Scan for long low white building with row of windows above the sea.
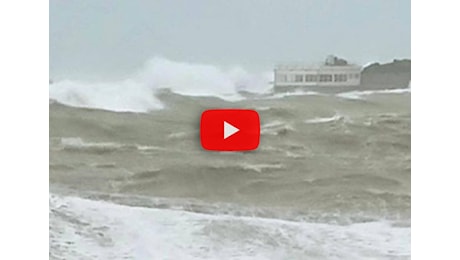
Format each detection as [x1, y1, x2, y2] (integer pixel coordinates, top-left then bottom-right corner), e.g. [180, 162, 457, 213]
[274, 56, 361, 90]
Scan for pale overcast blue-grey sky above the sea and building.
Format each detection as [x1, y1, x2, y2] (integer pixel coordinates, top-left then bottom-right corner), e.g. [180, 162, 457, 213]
[50, 0, 411, 78]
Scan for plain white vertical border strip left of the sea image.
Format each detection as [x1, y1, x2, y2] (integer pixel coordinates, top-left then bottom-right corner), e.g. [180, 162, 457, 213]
[0, 1, 49, 259]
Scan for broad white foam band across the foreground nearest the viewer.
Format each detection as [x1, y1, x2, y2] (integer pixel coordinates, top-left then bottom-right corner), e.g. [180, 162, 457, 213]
[50, 195, 410, 259]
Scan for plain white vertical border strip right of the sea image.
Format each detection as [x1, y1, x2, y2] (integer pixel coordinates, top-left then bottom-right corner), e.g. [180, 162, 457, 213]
[411, 1, 460, 259]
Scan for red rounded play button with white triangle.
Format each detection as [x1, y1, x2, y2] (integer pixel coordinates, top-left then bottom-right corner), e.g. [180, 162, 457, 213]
[200, 109, 260, 151]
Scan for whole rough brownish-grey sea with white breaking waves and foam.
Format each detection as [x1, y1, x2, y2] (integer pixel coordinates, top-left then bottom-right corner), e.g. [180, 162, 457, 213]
[49, 59, 411, 259]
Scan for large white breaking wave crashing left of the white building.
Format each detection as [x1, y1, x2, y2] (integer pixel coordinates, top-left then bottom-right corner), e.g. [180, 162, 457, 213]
[49, 57, 272, 112]
